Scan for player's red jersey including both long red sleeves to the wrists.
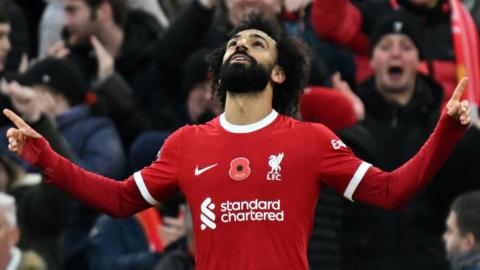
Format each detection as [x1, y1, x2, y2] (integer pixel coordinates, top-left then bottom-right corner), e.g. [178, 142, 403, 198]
[29, 108, 466, 270]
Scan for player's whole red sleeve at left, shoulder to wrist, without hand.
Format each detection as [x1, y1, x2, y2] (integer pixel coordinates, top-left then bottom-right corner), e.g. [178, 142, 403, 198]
[22, 127, 186, 217]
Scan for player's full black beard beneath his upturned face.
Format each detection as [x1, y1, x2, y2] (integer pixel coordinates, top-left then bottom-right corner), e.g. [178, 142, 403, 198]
[218, 52, 273, 94]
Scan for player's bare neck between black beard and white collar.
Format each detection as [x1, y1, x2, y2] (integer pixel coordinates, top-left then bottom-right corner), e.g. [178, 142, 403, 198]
[225, 84, 273, 125]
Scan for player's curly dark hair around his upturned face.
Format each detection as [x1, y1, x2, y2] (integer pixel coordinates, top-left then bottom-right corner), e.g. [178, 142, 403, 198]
[209, 13, 310, 115]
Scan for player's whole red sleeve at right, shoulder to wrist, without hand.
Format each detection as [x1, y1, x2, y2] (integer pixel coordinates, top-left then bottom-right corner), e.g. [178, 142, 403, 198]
[319, 113, 466, 209]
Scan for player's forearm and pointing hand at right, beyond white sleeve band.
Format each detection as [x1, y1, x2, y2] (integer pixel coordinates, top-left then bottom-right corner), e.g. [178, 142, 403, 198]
[354, 78, 470, 209]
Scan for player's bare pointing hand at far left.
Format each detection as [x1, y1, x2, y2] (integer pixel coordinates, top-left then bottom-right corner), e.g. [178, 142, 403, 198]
[3, 109, 42, 155]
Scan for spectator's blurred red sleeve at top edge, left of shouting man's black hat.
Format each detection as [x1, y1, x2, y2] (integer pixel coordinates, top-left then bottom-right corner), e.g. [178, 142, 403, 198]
[311, 0, 368, 54]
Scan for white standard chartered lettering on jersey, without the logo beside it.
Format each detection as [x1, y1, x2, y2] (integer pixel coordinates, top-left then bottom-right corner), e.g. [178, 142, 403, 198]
[220, 199, 285, 223]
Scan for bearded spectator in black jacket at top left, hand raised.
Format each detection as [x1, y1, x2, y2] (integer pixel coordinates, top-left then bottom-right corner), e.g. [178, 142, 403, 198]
[60, 0, 185, 134]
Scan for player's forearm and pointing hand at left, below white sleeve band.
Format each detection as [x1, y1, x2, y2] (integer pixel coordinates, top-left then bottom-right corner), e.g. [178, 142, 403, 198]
[3, 109, 150, 217]
